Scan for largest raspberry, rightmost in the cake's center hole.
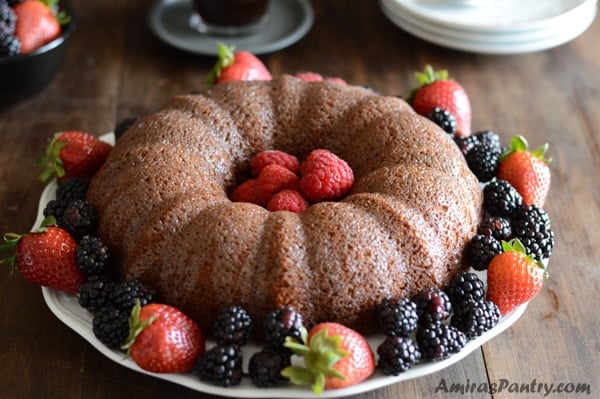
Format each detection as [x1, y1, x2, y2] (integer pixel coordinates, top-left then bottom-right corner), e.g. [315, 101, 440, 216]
[300, 149, 354, 202]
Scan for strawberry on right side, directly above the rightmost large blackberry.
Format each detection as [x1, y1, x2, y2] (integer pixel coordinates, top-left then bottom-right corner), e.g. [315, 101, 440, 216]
[497, 136, 550, 208]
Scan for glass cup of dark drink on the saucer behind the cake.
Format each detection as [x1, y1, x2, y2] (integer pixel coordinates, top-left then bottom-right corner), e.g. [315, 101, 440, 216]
[190, 0, 270, 36]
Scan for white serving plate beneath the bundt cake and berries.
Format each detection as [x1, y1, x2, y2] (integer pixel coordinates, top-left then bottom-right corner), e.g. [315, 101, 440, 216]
[34, 133, 527, 399]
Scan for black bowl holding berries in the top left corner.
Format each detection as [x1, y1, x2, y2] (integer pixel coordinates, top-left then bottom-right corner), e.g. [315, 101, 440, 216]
[0, 1, 77, 109]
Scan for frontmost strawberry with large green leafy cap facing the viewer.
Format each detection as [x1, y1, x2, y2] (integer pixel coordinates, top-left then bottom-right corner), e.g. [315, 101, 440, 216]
[281, 323, 375, 394]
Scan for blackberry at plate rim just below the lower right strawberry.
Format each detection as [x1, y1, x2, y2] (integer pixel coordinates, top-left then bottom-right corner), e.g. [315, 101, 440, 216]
[450, 300, 500, 338]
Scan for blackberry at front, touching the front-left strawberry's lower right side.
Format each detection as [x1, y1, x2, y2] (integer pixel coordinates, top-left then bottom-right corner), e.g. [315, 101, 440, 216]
[192, 344, 242, 387]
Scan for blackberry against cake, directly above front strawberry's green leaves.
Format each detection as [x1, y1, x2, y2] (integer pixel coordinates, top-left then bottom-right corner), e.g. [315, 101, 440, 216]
[263, 306, 303, 349]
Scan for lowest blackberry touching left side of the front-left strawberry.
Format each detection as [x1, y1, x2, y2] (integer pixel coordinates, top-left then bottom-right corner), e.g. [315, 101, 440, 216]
[92, 307, 129, 350]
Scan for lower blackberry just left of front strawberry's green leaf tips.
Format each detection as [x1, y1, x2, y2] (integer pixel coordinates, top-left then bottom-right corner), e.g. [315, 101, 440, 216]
[248, 347, 292, 388]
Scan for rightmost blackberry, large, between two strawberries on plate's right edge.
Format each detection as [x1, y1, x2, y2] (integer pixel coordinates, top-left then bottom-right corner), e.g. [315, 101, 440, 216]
[511, 205, 554, 261]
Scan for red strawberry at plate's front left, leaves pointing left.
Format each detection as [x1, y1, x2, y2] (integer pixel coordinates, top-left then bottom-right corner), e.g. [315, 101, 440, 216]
[122, 300, 206, 373]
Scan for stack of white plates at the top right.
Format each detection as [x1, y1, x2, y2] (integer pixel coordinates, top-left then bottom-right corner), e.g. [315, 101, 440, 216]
[380, 0, 598, 54]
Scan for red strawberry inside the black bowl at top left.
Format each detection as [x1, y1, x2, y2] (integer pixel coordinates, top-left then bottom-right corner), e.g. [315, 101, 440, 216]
[13, 0, 62, 54]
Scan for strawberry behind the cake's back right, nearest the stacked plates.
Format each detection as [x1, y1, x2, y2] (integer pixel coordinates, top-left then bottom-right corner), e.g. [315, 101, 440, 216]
[407, 65, 471, 137]
